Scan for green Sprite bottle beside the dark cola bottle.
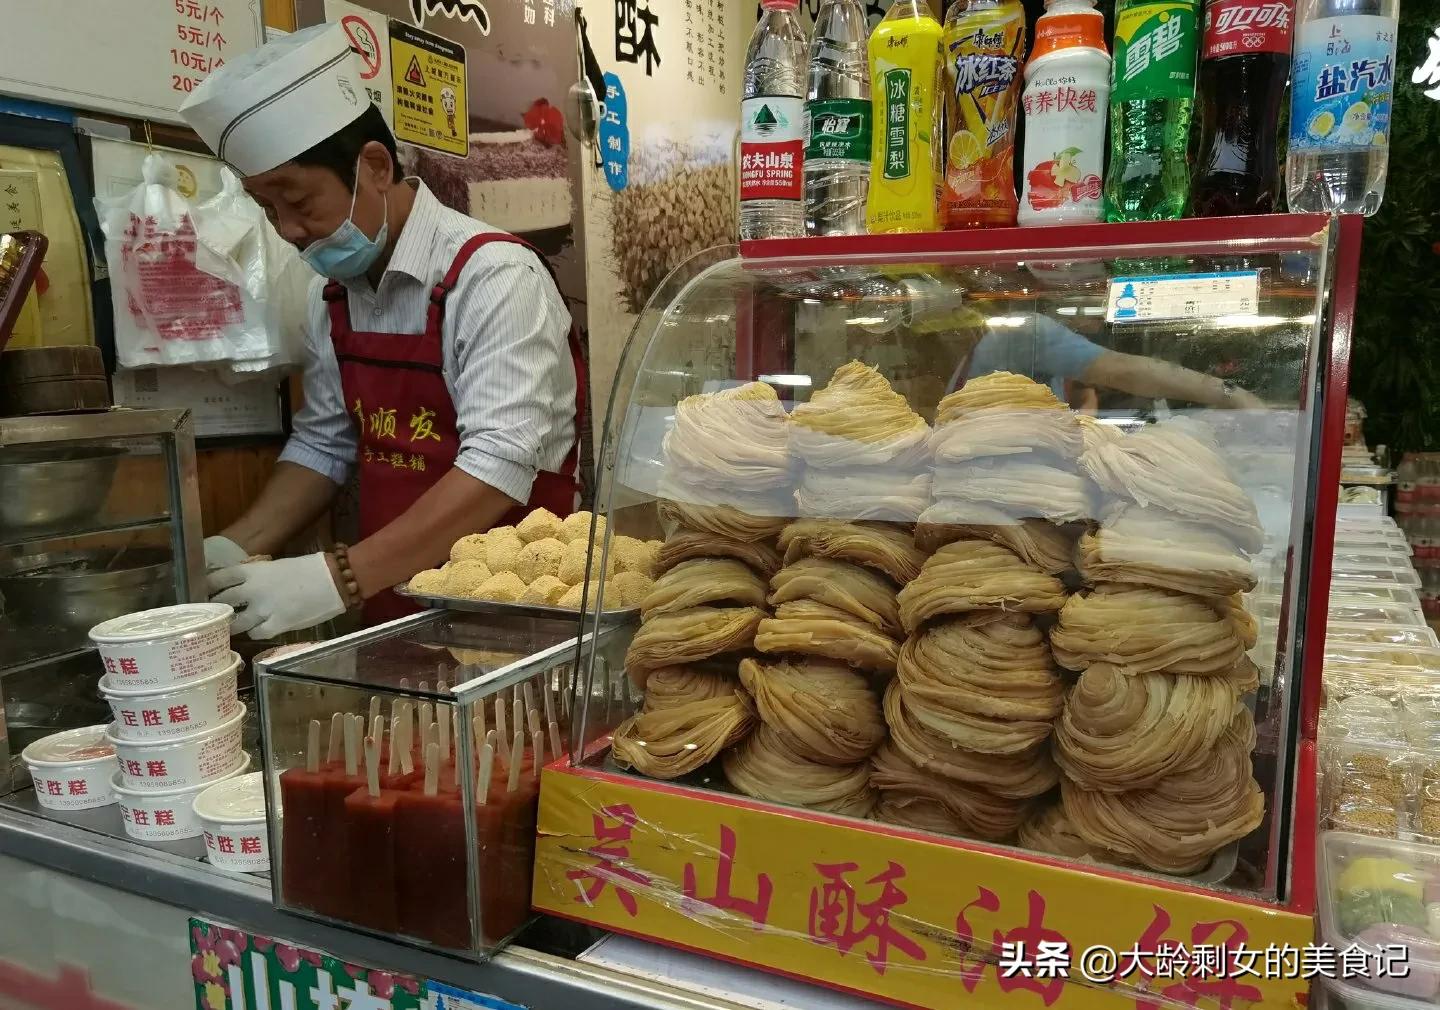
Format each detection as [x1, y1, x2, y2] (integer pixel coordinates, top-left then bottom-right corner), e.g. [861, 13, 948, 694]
[1104, 0, 1200, 220]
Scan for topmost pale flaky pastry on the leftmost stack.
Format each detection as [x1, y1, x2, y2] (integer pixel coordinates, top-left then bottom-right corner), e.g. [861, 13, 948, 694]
[665, 382, 793, 491]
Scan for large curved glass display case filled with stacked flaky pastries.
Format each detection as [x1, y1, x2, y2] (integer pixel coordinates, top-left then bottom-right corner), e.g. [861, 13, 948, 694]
[554, 216, 1347, 935]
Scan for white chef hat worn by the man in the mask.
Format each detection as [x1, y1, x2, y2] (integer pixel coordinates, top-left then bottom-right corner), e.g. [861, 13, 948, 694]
[180, 24, 370, 176]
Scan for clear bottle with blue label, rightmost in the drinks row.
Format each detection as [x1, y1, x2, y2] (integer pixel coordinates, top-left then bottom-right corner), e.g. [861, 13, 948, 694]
[1284, 0, 1400, 215]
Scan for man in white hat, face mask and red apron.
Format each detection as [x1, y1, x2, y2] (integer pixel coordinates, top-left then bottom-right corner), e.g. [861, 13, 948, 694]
[180, 24, 585, 638]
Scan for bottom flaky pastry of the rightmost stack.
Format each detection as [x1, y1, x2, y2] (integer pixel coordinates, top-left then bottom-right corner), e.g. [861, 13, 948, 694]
[1060, 713, 1264, 875]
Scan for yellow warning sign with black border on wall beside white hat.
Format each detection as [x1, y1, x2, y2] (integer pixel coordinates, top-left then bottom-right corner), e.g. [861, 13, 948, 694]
[390, 20, 469, 157]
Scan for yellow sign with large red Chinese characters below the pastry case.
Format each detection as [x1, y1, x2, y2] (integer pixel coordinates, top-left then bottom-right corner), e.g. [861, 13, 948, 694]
[533, 767, 1315, 1010]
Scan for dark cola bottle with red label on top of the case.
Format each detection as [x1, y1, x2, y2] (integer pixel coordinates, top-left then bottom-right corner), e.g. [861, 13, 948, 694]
[1191, 0, 1295, 218]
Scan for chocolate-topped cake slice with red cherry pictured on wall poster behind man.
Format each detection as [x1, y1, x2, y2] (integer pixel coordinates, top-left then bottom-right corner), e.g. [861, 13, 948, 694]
[402, 98, 575, 235]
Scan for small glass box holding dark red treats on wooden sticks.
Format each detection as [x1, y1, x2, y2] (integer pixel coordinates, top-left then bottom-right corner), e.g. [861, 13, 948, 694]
[256, 611, 603, 957]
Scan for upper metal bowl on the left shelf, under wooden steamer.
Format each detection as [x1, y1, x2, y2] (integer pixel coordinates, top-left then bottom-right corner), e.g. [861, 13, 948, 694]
[0, 445, 124, 533]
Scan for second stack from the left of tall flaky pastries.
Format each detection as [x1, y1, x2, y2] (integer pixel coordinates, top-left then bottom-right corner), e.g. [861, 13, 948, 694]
[723, 362, 930, 817]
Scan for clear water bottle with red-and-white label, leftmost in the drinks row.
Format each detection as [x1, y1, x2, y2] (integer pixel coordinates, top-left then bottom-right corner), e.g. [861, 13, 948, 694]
[740, 0, 805, 239]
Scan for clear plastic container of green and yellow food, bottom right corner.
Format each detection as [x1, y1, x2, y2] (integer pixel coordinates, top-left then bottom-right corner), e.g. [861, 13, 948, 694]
[1316, 831, 1440, 1009]
